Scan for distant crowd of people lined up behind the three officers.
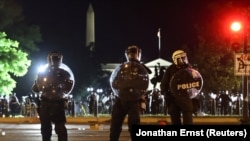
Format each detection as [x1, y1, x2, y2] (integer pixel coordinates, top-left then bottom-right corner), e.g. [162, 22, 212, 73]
[0, 88, 243, 117]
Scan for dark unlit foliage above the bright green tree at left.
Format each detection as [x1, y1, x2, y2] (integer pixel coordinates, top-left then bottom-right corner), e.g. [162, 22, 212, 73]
[0, 0, 42, 53]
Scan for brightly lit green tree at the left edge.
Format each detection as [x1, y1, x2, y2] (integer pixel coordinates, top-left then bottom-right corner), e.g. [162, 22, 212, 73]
[0, 32, 31, 95]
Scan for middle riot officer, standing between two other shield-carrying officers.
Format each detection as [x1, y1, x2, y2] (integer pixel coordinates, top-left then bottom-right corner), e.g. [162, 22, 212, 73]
[110, 46, 151, 141]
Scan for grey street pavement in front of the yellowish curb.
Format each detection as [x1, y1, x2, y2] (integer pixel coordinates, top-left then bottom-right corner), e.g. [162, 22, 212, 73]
[0, 123, 130, 141]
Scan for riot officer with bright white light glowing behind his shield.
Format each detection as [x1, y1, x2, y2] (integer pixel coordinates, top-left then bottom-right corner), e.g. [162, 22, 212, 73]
[32, 51, 74, 141]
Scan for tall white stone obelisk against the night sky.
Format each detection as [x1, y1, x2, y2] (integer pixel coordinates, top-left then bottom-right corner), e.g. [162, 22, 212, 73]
[86, 3, 95, 51]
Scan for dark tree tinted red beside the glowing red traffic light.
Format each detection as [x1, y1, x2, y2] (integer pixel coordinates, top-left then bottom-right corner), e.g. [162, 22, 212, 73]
[185, 2, 244, 93]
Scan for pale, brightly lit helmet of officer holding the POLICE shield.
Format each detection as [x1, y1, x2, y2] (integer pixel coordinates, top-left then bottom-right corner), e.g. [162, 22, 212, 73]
[172, 50, 188, 66]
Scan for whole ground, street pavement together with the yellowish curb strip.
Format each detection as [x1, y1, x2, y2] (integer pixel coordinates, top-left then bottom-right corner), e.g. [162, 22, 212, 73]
[0, 116, 246, 141]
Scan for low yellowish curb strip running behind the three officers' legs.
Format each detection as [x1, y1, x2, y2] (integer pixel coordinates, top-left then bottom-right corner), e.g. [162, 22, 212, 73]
[0, 115, 242, 124]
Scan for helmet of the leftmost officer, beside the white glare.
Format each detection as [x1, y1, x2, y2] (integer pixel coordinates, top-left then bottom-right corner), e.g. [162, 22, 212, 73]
[47, 51, 63, 67]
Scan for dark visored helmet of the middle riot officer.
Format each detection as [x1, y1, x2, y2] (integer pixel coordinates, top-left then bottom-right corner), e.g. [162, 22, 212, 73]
[125, 45, 141, 61]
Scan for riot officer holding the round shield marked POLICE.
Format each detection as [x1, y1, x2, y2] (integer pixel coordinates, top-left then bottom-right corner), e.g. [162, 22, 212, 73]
[160, 50, 202, 125]
